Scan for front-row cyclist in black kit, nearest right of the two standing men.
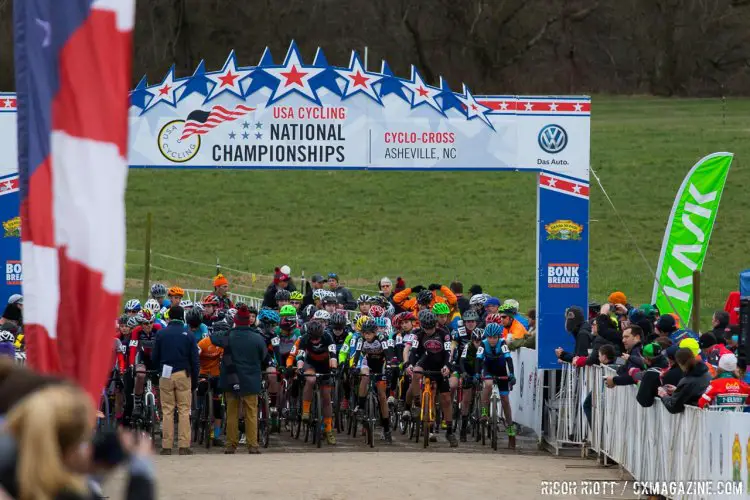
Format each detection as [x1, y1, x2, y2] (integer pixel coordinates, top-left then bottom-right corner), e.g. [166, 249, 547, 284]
[286, 321, 337, 445]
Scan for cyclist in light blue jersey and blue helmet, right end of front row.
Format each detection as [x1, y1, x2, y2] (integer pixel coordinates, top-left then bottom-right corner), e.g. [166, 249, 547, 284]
[476, 323, 516, 437]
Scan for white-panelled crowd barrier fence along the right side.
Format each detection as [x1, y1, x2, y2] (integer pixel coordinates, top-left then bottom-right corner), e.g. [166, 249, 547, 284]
[545, 363, 750, 499]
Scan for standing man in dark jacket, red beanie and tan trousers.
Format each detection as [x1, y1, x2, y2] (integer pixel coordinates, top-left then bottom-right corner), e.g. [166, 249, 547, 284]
[211, 305, 270, 454]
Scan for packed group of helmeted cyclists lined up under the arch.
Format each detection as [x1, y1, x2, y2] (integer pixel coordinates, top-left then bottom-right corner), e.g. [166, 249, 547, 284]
[111, 275, 528, 447]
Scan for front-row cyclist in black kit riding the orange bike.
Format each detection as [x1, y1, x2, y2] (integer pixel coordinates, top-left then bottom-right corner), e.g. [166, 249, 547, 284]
[403, 309, 458, 448]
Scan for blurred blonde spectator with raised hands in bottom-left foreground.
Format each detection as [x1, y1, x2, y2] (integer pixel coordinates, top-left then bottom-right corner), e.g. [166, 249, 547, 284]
[0, 384, 155, 500]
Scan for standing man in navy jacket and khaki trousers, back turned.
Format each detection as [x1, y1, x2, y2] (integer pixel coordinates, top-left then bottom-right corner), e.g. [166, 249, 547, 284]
[151, 306, 200, 455]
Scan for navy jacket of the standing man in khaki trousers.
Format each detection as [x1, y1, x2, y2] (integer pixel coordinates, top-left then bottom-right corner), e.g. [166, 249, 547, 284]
[151, 321, 200, 383]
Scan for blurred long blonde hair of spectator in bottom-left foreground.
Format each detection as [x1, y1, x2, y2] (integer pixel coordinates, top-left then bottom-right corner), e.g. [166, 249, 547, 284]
[5, 385, 94, 500]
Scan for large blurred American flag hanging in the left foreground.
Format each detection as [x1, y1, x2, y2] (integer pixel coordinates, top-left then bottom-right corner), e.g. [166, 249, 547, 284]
[13, 0, 135, 402]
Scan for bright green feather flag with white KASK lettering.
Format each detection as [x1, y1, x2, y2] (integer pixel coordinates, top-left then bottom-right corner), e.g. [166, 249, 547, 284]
[652, 153, 734, 326]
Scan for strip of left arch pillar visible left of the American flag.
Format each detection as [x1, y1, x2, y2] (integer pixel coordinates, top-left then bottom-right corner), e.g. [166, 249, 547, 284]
[0, 93, 23, 307]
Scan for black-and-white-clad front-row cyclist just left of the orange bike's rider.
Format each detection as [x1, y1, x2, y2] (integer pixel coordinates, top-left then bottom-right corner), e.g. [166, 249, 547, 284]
[352, 318, 394, 443]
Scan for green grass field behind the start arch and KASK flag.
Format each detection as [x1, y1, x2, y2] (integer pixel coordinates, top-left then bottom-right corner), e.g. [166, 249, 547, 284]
[127, 97, 750, 332]
